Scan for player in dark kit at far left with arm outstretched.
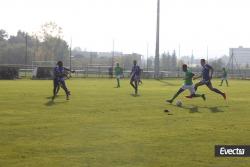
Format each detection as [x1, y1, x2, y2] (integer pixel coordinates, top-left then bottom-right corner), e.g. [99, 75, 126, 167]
[52, 61, 74, 100]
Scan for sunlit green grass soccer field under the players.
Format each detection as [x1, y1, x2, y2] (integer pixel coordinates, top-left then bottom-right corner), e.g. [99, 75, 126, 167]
[0, 79, 250, 167]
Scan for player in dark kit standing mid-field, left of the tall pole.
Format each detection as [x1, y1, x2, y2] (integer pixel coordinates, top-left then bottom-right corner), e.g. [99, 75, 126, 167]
[130, 60, 141, 95]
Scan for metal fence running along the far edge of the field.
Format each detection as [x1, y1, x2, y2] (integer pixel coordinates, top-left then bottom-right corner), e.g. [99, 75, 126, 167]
[0, 64, 250, 79]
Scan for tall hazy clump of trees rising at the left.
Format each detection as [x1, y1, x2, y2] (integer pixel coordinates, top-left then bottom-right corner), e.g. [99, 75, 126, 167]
[0, 22, 69, 65]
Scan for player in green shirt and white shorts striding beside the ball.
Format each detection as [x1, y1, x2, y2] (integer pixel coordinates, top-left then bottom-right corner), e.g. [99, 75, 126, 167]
[166, 64, 206, 103]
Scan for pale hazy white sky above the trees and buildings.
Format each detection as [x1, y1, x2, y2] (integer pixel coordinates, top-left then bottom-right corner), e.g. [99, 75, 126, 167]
[0, 0, 250, 58]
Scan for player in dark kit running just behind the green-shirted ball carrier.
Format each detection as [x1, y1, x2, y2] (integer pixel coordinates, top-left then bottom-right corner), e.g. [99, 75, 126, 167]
[194, 59, 226, 100]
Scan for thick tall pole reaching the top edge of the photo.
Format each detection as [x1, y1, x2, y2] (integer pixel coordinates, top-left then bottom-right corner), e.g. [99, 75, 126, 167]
[154, 0, 160, 79]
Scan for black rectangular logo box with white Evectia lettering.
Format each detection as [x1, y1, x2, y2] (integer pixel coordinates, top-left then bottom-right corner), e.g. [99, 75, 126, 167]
[215, 145, 250, 157]
